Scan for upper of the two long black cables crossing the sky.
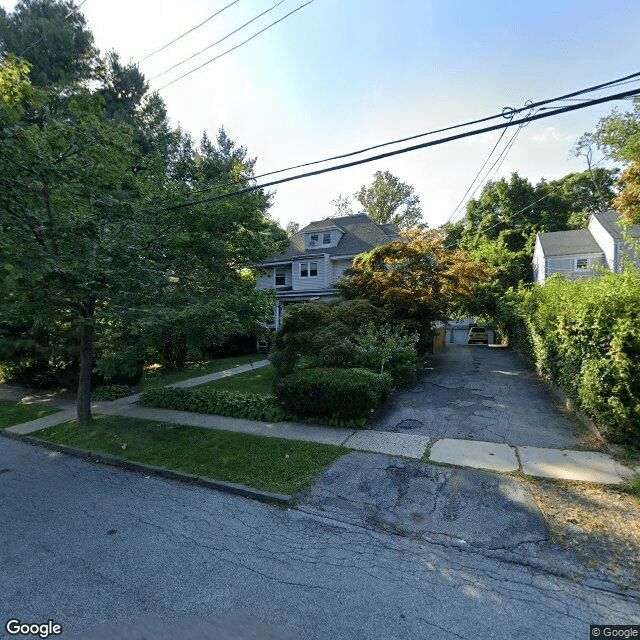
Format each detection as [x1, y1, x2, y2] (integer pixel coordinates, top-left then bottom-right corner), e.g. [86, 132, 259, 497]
[166, 72, 640, 201]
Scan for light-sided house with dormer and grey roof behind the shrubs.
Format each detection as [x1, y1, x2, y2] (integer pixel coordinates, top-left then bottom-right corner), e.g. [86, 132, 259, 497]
[256, 213, 400, 329]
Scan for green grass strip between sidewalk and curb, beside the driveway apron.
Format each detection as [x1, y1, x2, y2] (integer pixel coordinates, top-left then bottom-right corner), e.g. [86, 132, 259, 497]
[31, 416, 349, 495]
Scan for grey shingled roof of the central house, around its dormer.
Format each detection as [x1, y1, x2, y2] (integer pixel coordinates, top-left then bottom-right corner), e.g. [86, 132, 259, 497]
[265, 213, 400, 264]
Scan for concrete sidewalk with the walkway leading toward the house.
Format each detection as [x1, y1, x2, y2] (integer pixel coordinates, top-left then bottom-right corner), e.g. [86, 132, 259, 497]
[0, 360, 640, 484]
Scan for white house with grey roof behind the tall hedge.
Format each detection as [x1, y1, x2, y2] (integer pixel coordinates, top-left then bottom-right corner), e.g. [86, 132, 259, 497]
[533, 211, 640, 284]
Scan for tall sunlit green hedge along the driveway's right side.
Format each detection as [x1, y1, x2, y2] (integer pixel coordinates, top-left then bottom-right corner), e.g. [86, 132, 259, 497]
[498, 269, 640, 446]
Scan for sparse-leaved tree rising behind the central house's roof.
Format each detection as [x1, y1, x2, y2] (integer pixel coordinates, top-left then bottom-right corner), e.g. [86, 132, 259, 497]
[354, 171, 422, 229]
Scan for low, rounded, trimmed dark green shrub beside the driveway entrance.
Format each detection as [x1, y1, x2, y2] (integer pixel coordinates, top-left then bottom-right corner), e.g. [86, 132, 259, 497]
[275, 368, 393, 422]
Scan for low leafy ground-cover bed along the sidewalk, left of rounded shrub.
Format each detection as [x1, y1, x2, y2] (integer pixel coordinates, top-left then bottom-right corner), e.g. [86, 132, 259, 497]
[139, 387, 291, 422]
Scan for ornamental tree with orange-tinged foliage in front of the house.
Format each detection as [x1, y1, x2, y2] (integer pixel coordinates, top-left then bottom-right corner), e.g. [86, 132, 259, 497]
[337, 229, 489, 350]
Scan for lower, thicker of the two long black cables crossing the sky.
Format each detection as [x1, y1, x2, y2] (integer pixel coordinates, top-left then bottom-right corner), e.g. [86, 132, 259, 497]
[164, 88, 640, 211]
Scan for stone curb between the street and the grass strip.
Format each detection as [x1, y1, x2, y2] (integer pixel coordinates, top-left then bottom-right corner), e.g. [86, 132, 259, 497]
[0, 429, 295, 506]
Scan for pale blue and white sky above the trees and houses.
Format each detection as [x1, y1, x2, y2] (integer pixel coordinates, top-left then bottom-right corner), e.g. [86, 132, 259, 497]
[0, 0, 640, 227]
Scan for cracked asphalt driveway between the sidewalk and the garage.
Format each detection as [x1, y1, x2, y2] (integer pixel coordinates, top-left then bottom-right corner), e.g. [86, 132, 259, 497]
[369, 343, 580, 448]
